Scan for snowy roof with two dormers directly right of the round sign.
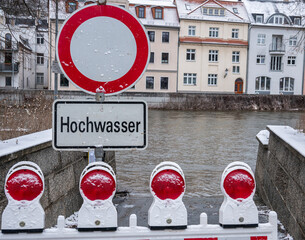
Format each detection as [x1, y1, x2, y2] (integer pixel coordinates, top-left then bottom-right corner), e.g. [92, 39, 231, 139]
[129, 0, 179, 27]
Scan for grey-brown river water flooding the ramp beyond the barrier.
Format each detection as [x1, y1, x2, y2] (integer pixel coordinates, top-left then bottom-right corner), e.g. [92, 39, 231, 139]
[116, 110, 305, 197]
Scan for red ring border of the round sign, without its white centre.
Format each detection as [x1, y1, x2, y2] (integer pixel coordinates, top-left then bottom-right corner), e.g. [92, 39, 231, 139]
[56, 5, 150, 95]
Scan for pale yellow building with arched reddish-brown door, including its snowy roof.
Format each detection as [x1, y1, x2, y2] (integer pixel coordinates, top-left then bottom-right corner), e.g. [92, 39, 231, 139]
[176, 0, 249, 93]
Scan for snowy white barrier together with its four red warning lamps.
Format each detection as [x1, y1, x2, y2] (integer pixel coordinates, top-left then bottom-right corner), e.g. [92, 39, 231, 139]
[0, 162, 277, 240]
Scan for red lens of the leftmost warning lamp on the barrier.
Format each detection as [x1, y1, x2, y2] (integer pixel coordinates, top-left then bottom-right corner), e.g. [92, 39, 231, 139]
[5, 169, 43, 201]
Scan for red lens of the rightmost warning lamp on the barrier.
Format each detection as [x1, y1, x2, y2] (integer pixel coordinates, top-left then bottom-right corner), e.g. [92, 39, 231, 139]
[223, 169, 255, 199]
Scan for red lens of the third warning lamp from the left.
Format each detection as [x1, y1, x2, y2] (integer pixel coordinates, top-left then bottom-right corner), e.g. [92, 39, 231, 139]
[151, 169, 185, 200]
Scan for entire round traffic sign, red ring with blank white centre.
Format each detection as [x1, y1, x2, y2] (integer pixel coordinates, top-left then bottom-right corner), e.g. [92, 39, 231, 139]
[56, 4, 150, 95]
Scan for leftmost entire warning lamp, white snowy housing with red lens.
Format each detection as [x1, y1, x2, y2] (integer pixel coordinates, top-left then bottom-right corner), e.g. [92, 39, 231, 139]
[1, 161, 45, 233]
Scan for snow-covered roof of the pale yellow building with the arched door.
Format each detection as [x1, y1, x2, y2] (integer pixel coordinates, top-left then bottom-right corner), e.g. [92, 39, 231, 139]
[176, 0, 249, 23]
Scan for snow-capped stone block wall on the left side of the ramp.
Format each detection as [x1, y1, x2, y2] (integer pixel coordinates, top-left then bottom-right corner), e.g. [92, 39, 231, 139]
[0, 130, 115, 227]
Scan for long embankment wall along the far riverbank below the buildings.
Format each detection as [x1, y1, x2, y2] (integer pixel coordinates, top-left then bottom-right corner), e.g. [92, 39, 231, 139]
[0, 89, 305, 111]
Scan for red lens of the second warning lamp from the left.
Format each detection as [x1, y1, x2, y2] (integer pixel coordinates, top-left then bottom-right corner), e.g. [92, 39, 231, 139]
[80, 170, 115, 201]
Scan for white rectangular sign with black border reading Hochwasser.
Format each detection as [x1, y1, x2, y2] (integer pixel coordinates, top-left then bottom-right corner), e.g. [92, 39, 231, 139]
[53, 100, 147, 150]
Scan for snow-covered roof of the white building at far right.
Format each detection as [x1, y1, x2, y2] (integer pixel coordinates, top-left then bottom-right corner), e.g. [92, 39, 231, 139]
[244, 0, 305, 24]
